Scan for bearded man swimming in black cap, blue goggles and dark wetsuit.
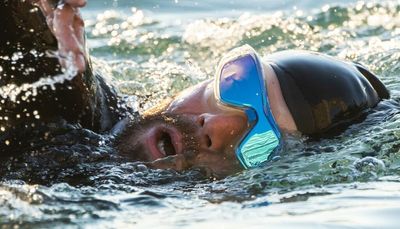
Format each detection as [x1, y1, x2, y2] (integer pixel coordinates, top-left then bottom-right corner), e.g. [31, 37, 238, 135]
[0, 0, 389, 176]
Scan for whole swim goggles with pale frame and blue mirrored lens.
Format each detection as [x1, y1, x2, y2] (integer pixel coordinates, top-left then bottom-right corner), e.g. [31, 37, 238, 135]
[214, 45, 281, 169]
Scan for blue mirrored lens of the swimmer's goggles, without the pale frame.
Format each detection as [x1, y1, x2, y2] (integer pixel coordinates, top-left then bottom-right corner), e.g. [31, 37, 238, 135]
[217, 54, 280, 168]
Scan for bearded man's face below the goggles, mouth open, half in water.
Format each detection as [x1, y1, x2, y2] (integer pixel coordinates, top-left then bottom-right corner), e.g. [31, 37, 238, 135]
[118, 81, 248, 175]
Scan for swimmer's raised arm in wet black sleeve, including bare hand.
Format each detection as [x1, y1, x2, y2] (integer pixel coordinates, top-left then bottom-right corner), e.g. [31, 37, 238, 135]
[0, 0, 130, 154]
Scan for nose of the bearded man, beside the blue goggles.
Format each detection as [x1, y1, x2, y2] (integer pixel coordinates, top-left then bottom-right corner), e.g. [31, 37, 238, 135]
[197, 113, 247, 152]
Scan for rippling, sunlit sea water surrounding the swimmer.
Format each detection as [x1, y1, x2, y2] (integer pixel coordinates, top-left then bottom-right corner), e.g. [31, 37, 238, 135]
[0, 0, 400, 228]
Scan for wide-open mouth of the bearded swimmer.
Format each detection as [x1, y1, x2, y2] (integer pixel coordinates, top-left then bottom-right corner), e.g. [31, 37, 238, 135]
[147, 126, 183, 160]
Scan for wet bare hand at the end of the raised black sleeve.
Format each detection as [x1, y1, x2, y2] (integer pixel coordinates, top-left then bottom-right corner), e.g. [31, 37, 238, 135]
[29, 0, 86, 72]
